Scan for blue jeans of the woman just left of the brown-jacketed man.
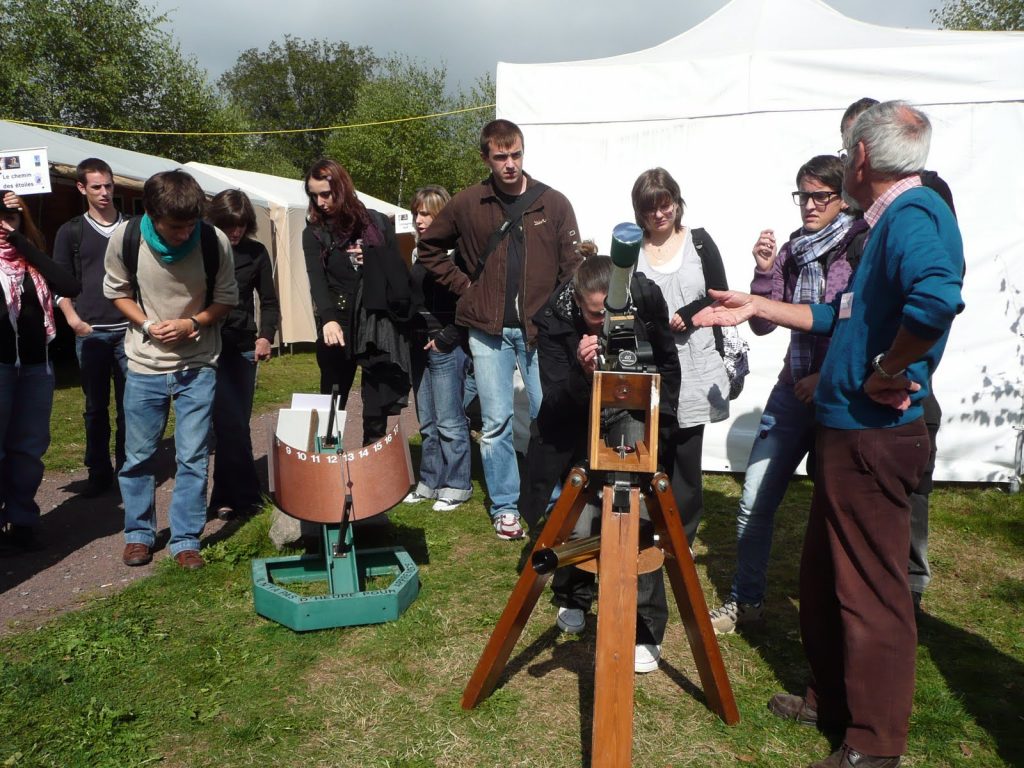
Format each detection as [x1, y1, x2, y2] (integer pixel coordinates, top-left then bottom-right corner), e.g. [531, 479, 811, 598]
[413, 346, 473, 502]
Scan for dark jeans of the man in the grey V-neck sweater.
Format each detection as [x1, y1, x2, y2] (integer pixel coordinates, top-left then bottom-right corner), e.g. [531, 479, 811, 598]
[75, 329, 128, 477]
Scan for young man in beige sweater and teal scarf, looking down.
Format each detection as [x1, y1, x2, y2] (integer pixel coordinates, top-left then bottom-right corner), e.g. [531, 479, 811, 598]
[103, 171, 239, 569]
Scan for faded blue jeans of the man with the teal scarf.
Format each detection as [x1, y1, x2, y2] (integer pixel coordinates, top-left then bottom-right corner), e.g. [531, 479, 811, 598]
[118, 367, 217, 556]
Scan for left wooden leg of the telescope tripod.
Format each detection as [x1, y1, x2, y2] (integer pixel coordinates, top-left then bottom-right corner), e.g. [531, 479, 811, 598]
[462, 467, 593, 710]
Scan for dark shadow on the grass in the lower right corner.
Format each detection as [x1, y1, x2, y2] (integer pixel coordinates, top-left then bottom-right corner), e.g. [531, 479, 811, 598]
[915, 603, 1024, 766]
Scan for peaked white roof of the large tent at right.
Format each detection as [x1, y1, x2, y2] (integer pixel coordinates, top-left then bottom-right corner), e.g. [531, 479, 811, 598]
[498, 0, 1024, 125]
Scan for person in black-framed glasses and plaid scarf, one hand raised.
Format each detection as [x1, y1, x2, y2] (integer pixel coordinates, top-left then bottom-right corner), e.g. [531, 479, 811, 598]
[711, 155, 867, 634]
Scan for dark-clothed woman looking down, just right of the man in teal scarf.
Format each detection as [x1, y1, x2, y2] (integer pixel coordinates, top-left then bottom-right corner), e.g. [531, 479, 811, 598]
[206, 189, 281, 520]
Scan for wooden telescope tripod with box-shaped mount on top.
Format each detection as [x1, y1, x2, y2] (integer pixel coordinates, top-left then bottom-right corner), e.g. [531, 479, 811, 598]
[462, 225, 739, 768]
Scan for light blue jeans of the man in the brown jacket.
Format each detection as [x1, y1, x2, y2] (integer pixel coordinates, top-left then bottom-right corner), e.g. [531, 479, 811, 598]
[469, 328, 542, 517]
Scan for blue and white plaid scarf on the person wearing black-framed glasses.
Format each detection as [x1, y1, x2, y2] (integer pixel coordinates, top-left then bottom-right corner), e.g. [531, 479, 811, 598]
[790, 213, 854, 381]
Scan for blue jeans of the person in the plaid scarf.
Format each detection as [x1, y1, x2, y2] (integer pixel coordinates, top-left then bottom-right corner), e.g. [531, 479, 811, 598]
[730, 382, 814, 603]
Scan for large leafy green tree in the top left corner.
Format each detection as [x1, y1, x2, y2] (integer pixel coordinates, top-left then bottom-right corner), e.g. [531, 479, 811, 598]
[0, 0, 238, 162]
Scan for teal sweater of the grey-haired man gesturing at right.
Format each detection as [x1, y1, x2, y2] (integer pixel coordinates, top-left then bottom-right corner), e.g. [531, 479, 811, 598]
[811, 187, 964, 429]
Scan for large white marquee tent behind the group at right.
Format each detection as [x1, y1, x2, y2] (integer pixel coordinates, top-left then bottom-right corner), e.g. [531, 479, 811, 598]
[497, 0, 1024, 484]
